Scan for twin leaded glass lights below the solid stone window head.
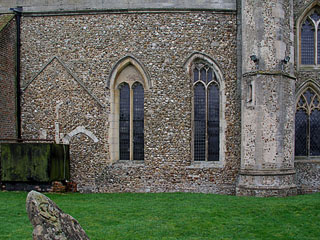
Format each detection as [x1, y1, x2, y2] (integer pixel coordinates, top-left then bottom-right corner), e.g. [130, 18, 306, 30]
[118, 82, 144, 160]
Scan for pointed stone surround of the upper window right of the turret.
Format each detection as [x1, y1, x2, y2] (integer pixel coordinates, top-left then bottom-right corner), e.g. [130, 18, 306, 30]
[295, 0, 320, 71]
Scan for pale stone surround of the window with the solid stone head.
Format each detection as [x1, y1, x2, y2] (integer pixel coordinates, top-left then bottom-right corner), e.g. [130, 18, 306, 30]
[107, 55, 152, 164]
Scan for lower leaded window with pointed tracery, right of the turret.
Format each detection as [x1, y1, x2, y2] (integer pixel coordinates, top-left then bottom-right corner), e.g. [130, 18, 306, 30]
[295, 88, 320, 156]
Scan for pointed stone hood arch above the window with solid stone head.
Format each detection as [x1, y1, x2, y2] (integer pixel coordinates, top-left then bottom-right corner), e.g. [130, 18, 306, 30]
[106, 55, 153, 90]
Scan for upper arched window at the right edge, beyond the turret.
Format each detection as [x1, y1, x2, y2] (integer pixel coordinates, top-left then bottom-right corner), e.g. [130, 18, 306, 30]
[300, 7, 320, 65]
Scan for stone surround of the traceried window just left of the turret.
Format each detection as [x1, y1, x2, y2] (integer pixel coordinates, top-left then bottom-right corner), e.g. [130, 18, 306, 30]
[183, 52, 227, 167]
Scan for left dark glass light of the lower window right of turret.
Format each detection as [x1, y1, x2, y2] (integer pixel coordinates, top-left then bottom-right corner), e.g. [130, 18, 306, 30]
[295, 109, 308, 156]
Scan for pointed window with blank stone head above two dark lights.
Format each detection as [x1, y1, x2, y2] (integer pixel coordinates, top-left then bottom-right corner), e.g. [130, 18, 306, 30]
[108, 62, 148, 161]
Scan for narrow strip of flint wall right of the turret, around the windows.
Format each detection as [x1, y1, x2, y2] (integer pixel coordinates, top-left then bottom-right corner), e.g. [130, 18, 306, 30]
[293, 0, 320, 193]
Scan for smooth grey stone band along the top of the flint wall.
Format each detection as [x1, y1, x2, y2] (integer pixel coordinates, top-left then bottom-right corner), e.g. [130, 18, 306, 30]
[0, 0, 236, 13]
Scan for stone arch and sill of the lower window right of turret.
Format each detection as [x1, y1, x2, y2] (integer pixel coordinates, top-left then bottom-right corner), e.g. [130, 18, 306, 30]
[294, 80, 320, 163]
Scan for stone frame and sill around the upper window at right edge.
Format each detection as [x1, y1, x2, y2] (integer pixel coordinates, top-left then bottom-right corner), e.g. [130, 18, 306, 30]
[295, 1, 320, 71]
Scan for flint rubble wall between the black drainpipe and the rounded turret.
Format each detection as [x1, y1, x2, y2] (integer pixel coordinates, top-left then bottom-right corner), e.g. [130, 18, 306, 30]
[21, 11, 241, 194]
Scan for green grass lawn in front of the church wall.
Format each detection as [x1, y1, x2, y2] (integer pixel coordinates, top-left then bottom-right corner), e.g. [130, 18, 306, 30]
[0, 192, 320, 240]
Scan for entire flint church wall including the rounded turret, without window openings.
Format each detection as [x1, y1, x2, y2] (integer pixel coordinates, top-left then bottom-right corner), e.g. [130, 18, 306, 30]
[0, 0, 320, 196]
